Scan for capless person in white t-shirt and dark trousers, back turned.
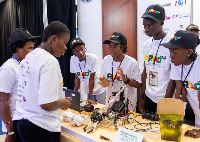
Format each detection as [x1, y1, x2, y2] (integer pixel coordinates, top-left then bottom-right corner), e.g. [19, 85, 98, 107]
[13, 21, 70, 142]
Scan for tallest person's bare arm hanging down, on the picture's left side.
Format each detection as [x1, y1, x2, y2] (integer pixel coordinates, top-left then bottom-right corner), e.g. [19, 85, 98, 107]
[138, 62, 147, 113]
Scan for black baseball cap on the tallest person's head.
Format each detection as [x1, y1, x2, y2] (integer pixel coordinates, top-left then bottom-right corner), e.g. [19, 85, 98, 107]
[142, 4, 165, 23]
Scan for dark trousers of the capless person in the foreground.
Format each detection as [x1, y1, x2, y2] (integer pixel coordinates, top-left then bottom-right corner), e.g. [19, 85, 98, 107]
[13, 119, 60, 142]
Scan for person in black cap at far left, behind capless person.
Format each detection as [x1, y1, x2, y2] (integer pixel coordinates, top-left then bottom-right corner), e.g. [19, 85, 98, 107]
[0, 28, 40, 141]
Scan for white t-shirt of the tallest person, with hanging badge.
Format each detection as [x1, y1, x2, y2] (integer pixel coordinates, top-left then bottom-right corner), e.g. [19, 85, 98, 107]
[143, 34, 171, 103]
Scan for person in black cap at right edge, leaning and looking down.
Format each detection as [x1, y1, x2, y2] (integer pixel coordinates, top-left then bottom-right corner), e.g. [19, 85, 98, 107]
[163, 30, 200, 127]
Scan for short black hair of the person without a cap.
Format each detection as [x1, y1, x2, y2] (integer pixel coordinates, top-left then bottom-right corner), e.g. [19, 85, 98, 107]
[42, 21, 70, 42]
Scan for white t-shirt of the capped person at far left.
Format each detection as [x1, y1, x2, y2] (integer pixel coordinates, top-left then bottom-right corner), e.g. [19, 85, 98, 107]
[0, 58, 19, 132]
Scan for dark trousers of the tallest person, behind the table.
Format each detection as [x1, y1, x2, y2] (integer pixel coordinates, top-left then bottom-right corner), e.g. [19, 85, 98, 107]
[144, 95, 157, 114]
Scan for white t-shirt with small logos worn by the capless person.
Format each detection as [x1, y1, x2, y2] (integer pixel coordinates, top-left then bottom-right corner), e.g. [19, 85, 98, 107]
[13, 48, 65, 132]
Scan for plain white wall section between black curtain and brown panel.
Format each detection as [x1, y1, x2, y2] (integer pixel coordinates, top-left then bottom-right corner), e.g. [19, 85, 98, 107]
[77, 0, 103, 68]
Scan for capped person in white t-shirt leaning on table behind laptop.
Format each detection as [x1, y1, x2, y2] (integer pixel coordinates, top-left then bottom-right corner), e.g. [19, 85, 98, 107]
[70, 38, 106, 105]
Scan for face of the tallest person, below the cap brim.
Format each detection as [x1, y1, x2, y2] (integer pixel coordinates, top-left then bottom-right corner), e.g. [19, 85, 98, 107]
[143, 18, 163, 37]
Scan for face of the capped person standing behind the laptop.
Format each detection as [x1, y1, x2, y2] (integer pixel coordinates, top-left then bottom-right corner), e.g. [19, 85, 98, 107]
[72, 44, 86, 61]
